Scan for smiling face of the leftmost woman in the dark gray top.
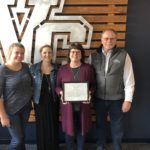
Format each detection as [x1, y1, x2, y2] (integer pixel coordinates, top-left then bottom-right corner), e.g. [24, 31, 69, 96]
[9, 46, 25, 63]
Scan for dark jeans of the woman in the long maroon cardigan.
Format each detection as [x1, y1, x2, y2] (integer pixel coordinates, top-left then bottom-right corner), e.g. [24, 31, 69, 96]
[65, 111, 85, 150]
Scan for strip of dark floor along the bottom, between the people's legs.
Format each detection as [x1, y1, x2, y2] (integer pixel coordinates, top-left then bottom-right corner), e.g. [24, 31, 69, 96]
[0, 143, 150, 150]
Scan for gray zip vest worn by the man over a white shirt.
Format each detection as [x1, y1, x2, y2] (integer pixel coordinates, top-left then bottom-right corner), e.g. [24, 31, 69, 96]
[91, 48, 127, 100]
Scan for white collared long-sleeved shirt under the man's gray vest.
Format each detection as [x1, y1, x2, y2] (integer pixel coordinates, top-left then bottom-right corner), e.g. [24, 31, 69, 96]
[102, 50, 135, 102]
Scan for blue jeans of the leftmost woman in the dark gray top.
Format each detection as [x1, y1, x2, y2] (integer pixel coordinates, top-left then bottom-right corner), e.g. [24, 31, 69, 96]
[8, 108, 30, 150]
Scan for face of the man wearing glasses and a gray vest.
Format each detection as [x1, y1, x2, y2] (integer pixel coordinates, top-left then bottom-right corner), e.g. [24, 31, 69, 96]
[101, 30, 117, 52]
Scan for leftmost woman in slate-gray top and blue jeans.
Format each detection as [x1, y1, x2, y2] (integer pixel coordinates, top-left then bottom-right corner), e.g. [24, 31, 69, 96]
[0, 43, 32, 150]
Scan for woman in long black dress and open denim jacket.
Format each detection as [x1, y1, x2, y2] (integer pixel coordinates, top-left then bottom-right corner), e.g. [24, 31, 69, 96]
[30, 45, 59, 150]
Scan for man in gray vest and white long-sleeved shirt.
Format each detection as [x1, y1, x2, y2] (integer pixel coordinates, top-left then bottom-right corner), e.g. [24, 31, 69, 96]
[90, 29, 135, 150]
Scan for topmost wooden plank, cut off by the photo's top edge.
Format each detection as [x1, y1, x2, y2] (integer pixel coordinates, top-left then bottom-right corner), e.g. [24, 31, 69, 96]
[65, 0, 128, 5]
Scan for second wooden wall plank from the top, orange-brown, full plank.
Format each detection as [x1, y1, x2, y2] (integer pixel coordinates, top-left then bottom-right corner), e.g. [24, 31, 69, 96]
[61, 5, 127, 15]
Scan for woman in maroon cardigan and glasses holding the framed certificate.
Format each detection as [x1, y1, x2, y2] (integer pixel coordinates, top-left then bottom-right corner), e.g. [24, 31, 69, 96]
[56, 43, 95, 150]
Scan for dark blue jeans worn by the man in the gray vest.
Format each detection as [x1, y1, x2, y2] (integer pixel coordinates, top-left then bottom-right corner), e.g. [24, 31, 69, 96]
[95, 99, 123, 150]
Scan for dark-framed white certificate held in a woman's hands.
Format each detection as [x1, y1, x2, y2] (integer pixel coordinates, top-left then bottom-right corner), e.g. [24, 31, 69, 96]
[63, 82, 89, 102]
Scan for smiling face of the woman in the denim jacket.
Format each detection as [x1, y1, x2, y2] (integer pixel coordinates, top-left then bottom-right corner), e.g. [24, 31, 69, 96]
[41, 47, 53, 63]
